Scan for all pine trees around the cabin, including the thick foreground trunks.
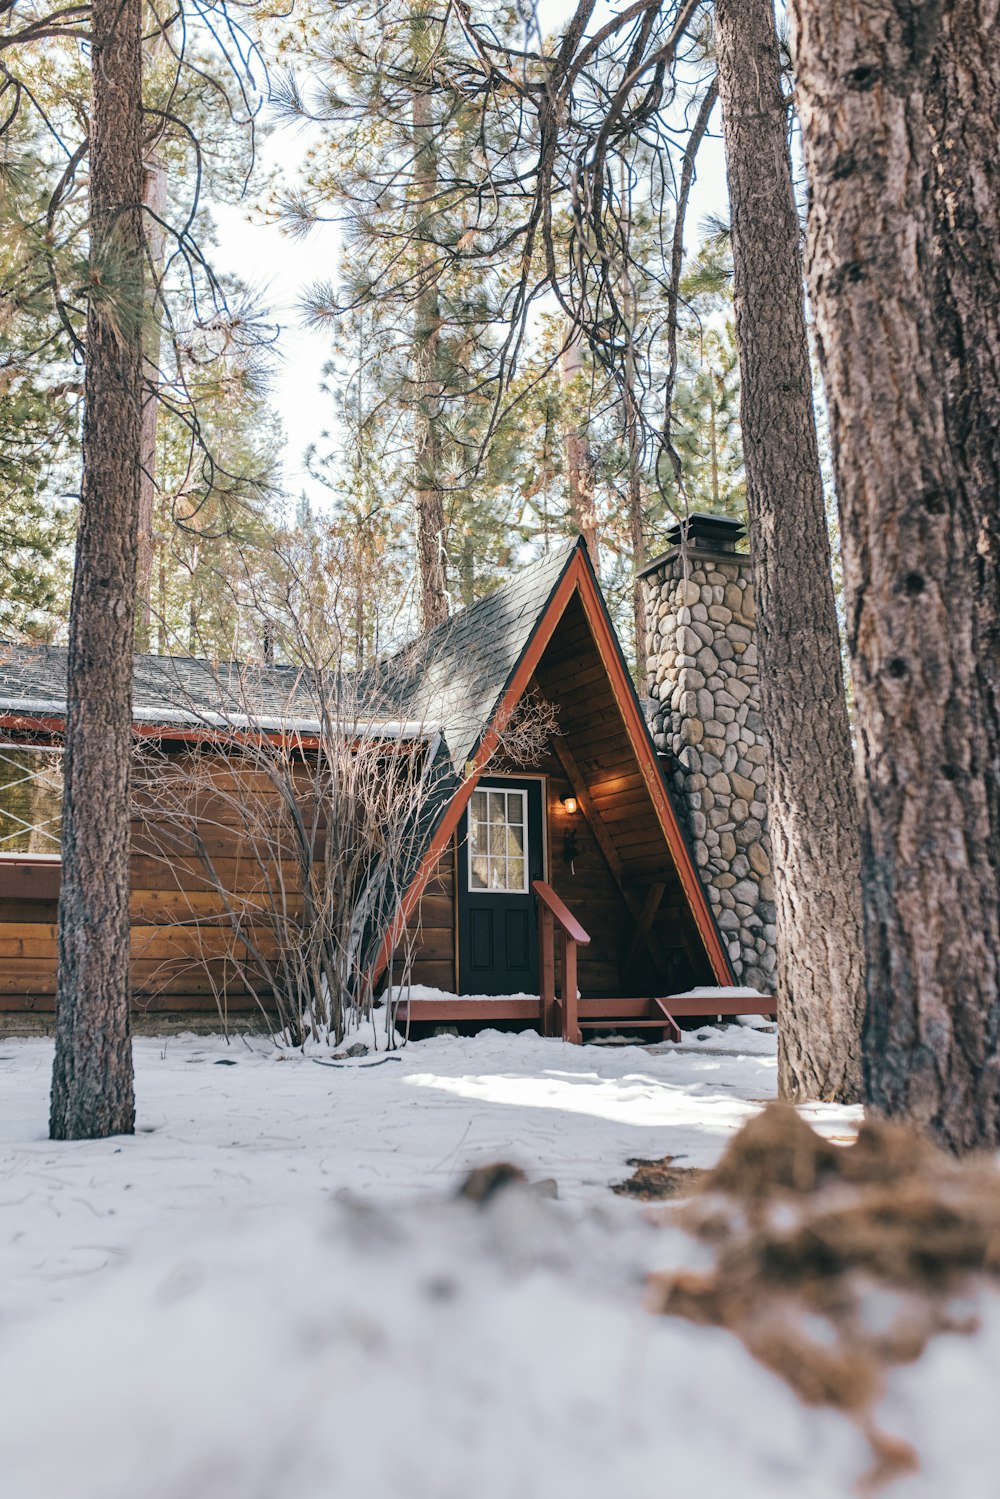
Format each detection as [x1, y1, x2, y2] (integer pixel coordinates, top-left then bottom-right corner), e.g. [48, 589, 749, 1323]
[0, 0, 1000, 1148]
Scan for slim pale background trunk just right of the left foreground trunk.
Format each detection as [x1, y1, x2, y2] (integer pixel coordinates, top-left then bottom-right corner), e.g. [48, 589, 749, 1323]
[136, 156, 166, 651]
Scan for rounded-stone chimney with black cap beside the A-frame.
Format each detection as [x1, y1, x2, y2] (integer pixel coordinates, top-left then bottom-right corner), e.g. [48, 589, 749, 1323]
[640, 514, 777, 992]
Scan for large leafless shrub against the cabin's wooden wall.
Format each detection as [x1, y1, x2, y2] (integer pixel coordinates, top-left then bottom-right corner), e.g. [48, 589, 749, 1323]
[133, 560, 556, 1045]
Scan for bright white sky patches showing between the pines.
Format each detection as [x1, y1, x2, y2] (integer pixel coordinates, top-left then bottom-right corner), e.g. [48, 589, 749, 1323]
[211, 0, 726, 511]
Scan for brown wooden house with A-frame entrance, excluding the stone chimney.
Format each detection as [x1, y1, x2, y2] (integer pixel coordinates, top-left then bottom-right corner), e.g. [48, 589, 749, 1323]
[0, 543, 772, 1039]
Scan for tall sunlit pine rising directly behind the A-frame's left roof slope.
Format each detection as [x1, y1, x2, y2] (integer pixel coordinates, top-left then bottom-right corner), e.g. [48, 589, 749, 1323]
[285, 0, 548, 614]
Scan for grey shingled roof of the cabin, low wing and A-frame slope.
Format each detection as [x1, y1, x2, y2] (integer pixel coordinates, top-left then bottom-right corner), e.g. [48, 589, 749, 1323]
[0, 543, 580, 773]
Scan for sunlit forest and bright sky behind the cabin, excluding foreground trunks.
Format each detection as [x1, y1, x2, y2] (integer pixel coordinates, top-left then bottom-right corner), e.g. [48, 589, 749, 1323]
[0, 0, 767, 685]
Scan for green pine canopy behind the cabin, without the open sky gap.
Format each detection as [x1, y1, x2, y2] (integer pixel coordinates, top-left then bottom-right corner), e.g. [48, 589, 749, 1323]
[0, 3, 742, 661]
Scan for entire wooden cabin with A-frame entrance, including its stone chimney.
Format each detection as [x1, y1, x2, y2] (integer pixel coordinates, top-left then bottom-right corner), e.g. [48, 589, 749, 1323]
[0, 517, 774, 1039]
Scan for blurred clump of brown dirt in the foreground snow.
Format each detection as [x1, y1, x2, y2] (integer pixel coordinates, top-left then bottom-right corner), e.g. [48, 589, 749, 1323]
[651, 1103, 1000, 1487]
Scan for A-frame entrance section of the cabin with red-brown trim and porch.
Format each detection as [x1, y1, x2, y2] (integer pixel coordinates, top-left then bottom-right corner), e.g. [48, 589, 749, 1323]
[379, 541, 761, 1039]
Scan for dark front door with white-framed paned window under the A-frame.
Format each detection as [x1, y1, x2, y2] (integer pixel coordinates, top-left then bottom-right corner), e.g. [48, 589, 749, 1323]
[457, 776, 546, 994]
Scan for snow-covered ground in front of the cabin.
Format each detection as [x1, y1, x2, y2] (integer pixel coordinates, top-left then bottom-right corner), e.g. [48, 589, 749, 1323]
[0, 1027, 1000, 1499]
